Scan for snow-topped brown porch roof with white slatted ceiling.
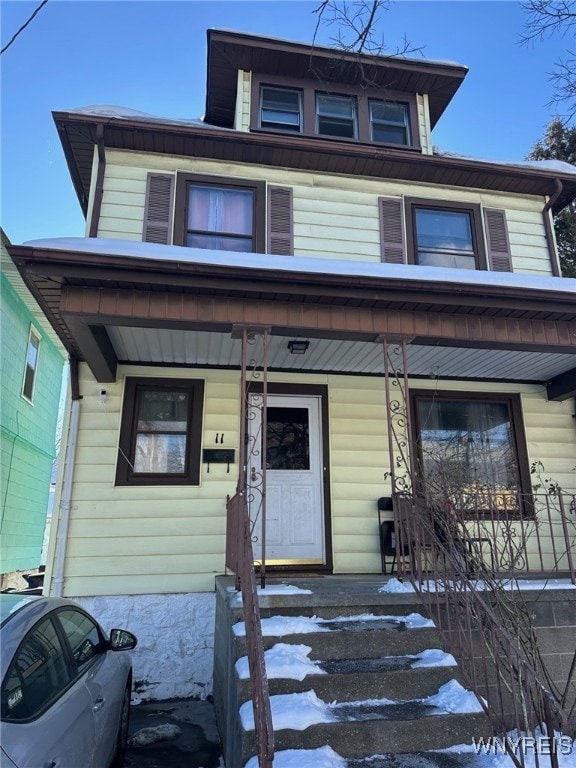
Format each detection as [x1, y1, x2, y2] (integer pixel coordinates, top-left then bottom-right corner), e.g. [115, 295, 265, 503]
[10, 238, 576, 399]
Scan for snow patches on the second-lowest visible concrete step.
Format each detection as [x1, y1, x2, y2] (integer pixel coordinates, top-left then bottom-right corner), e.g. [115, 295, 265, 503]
[240, 680, 482, 731]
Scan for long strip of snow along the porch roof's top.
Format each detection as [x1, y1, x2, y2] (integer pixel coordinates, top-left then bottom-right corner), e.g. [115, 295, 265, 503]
[23, 237, 576, 295]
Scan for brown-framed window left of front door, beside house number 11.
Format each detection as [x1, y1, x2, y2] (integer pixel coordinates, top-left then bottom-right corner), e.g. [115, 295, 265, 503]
[116, 377, 204, 485]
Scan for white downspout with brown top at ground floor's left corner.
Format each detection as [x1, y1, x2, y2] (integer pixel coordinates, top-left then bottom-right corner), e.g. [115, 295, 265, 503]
[50, 358, 82, 597]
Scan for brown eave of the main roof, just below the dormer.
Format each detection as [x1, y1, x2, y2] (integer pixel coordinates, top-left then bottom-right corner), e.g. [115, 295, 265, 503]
[53, 112, 576, 215]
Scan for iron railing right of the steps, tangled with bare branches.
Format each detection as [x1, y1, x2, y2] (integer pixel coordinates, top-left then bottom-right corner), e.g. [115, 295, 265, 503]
[394, 493, 576, 768]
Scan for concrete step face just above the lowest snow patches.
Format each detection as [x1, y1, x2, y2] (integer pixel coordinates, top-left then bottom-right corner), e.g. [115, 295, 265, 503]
[242, 702, 492, 768]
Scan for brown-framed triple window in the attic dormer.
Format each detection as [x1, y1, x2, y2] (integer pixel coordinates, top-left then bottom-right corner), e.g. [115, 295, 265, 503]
[250, 74, 420, 149]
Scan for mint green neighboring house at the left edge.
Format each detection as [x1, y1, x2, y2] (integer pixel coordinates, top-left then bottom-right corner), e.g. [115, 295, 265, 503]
[0, 230, 65, 574]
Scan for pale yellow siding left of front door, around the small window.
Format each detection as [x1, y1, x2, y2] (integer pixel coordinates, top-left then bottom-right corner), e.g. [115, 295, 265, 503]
[48, 365, 239, 596]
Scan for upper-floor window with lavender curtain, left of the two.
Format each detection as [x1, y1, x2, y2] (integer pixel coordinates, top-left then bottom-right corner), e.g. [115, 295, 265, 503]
[174, 173, 266, 253]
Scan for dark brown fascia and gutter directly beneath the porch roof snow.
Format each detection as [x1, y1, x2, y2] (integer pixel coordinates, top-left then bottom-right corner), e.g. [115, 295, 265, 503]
[9, 245, 576, 321]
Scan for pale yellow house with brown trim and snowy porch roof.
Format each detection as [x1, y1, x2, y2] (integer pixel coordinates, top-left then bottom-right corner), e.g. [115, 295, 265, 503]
[10, 30, 576, 698]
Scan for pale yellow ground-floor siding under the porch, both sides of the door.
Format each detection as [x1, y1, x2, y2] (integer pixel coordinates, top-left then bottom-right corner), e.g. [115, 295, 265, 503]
[47, 365, 576, 596]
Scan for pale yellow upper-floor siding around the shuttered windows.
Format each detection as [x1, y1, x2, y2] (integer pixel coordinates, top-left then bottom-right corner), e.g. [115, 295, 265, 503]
[98, 151, 552, 275]
